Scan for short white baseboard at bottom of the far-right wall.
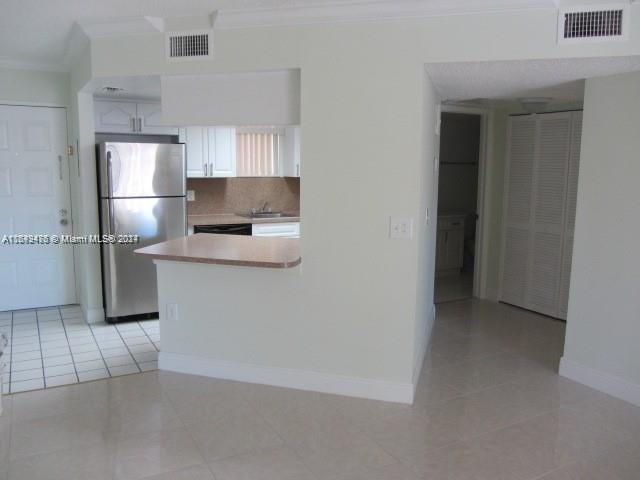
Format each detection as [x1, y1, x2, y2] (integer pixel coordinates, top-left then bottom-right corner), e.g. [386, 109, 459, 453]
[560, 357, 640, 406]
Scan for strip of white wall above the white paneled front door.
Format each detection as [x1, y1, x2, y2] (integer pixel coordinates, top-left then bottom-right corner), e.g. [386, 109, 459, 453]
[0, 67, 69, 106]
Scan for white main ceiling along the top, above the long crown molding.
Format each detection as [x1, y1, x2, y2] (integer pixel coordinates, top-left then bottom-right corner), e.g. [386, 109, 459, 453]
[0, 0, 555, 66]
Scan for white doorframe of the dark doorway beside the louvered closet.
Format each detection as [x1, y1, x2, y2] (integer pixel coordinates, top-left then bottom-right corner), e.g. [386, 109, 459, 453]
[438, 102, 495, 299]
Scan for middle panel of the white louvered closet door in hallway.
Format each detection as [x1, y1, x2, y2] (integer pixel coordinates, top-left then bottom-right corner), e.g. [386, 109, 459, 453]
[527, 112, 571, 317]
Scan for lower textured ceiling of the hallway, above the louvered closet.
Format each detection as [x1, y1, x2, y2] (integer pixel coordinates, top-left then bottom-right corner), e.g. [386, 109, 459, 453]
[426, 56, 640, 102]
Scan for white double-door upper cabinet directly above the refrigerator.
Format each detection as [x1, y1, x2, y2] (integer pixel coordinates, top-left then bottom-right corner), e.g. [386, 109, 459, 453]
[93, 100, 178, 135]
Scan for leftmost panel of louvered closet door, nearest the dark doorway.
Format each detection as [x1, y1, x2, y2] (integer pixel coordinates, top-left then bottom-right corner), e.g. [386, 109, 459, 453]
[500, 116, 536, 306]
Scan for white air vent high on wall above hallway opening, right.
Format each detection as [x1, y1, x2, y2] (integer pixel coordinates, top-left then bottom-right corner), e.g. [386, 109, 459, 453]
[558, 4, 630, 44]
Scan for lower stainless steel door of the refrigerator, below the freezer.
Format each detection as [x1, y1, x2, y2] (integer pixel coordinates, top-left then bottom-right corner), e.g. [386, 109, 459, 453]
[101, 197, 186, 321]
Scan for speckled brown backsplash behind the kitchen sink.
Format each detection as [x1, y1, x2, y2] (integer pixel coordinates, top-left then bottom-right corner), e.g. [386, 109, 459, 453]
[187, 177, 300, 215]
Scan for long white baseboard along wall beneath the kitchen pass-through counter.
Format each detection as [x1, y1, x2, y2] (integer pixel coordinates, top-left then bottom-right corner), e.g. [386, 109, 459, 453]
[158, 352, 413, 404]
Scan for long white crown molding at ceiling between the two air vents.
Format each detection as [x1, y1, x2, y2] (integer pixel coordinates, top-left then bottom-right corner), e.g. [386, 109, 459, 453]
[216, 0, 557, 28]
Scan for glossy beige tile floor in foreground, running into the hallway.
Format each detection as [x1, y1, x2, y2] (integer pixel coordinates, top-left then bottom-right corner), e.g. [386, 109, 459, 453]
[0, 301, 640, 480]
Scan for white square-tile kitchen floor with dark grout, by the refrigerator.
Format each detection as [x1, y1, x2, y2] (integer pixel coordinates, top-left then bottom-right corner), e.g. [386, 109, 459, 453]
[0, 305, 160, 393]
